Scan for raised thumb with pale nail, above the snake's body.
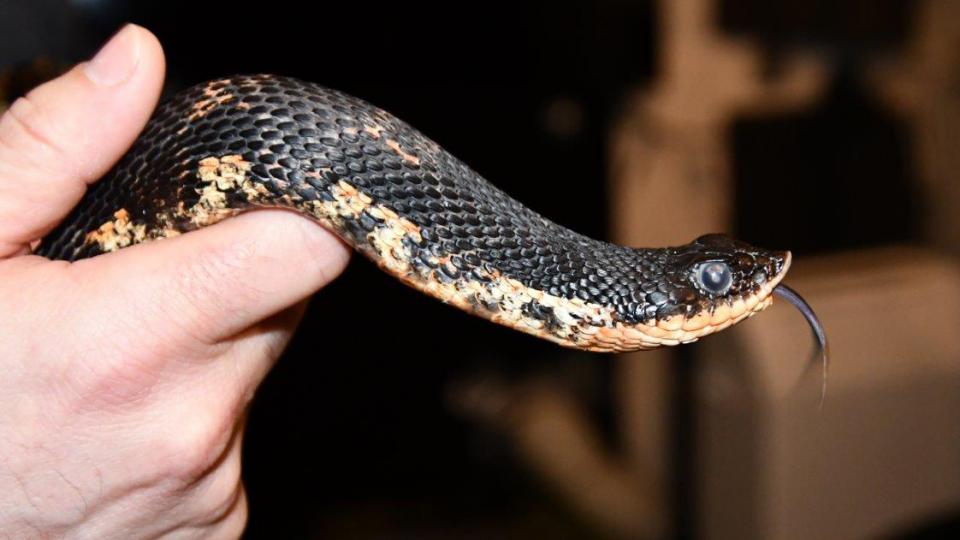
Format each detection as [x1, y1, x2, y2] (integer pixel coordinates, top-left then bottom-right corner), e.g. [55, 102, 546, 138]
[0, 25, 164, 258]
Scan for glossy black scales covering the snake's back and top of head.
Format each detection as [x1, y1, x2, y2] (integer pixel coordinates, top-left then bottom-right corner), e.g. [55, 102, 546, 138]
[38, 76, 783, 330]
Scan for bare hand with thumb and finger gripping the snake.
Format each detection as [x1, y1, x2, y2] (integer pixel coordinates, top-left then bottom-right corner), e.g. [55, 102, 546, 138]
[0, 26, 349, 538]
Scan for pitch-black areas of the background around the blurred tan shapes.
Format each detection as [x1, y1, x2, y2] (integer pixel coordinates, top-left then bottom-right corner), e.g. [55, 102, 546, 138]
[0, 0, 921, 538]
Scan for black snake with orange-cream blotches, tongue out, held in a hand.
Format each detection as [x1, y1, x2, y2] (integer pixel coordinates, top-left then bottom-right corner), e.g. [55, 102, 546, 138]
[35, 75, 826, 366]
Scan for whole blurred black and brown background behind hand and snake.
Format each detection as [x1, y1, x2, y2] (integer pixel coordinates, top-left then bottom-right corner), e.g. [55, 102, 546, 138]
[0, 0, 960, 539]
